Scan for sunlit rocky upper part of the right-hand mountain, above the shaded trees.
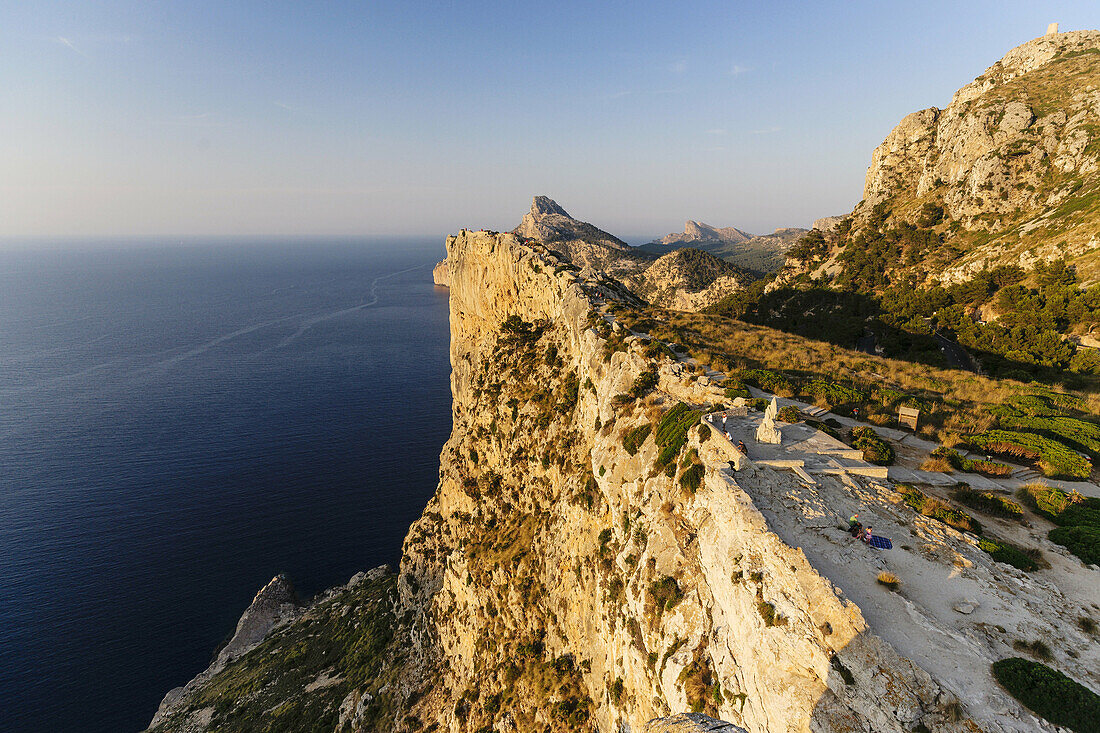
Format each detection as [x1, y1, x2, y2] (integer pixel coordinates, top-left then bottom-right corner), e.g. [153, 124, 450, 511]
[831, 31, 1100, 283]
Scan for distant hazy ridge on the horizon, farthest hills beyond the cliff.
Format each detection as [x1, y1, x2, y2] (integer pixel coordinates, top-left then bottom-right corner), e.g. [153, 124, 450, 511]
[638, 221, 807, 275]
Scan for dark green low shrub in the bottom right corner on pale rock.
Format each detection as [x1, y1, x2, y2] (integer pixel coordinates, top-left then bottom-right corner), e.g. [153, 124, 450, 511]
[991, 657, 1100, 733]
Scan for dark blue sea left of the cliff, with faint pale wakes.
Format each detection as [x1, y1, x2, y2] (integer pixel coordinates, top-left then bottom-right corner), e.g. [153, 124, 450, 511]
[0, 239, 451, 733]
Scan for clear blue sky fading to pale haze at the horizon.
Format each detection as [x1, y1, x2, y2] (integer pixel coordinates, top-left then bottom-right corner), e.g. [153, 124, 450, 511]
[0, 0, 1100, 241]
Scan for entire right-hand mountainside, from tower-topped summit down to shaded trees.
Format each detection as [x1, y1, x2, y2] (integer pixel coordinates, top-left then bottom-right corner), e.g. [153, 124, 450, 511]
[739, 31, 1100, 383]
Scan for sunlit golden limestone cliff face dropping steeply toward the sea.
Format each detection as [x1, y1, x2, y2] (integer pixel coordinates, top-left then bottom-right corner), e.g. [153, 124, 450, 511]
[389, 232, 972, 732]
